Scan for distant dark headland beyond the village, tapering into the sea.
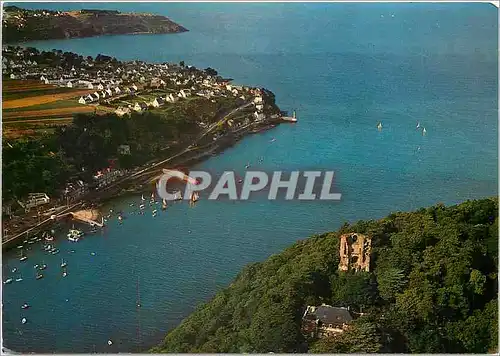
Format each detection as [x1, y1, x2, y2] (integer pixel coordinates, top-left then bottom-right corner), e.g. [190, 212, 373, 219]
[2, 6, 187, 43]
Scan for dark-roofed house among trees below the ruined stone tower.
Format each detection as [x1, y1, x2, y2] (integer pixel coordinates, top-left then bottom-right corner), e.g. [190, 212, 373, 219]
[302, 304, 355, 337]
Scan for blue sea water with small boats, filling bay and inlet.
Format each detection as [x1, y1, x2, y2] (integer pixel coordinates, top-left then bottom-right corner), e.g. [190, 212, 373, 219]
[3, 3, 498, 352]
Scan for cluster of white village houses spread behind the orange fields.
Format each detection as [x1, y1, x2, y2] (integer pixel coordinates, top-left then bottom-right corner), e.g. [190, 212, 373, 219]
[2, 47, 265, 124]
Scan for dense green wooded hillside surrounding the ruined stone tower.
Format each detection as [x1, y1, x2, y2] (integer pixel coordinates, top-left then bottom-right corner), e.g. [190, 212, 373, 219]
[151, 198, 498, 353]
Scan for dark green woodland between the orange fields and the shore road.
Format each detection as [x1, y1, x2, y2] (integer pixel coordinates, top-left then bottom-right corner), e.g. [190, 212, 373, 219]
[2, 98, 238, 202]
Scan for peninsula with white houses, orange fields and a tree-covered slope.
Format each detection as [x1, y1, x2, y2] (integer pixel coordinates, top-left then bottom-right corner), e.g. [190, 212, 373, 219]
[2, 46, 290, 247]
